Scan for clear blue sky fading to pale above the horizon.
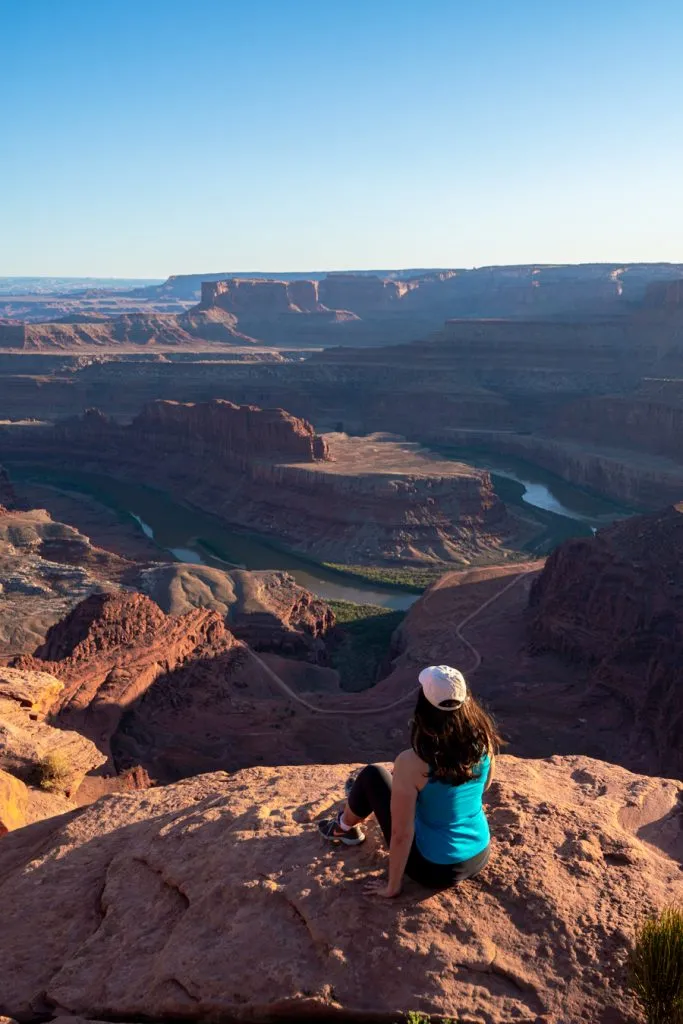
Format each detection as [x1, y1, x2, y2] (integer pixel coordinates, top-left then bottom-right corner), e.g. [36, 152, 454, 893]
[0, 0, 683, 276]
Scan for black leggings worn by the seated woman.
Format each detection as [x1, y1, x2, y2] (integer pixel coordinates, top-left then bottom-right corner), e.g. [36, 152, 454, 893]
[348, 765, 490, 889]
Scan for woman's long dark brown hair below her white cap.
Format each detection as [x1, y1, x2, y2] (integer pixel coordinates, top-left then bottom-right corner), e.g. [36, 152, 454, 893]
[411, 689, 503, 785]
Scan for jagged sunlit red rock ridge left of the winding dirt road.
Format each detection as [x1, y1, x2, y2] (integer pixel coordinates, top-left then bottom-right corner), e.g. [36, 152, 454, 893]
[14, 579, 337, 781]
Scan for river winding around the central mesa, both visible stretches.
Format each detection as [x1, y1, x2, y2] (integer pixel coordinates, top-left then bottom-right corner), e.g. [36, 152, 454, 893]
[11, 449, 630, 609]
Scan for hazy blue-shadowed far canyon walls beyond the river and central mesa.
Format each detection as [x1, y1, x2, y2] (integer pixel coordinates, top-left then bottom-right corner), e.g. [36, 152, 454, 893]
[0, 266, 683, 520]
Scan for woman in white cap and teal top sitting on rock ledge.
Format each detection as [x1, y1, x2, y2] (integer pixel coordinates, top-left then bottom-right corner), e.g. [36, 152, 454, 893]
[318, 665, 501, 899]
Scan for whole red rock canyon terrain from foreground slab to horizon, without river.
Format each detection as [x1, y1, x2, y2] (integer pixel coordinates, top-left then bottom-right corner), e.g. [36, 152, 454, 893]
[0, 266, 683, 1024]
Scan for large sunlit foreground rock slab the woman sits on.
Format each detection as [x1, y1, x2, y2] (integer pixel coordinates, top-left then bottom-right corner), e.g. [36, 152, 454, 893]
[0, 757, 683, 1024]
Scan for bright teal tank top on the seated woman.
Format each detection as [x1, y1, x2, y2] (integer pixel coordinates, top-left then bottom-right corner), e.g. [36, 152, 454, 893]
[415, 754, 490, 864]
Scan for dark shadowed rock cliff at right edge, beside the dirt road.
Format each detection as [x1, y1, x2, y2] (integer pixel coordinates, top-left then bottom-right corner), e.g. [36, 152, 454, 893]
[529, 505, 683, 777]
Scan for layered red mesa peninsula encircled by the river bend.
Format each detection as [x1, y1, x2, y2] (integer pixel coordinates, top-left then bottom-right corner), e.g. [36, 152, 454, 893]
[0, 400, 507, 564]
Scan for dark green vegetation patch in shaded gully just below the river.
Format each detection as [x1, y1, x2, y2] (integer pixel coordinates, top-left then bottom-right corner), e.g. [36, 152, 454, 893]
[328, 601, 404, 692]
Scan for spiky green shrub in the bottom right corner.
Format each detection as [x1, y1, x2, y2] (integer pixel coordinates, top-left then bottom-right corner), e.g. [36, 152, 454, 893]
[629, 907, 683, 1024]
